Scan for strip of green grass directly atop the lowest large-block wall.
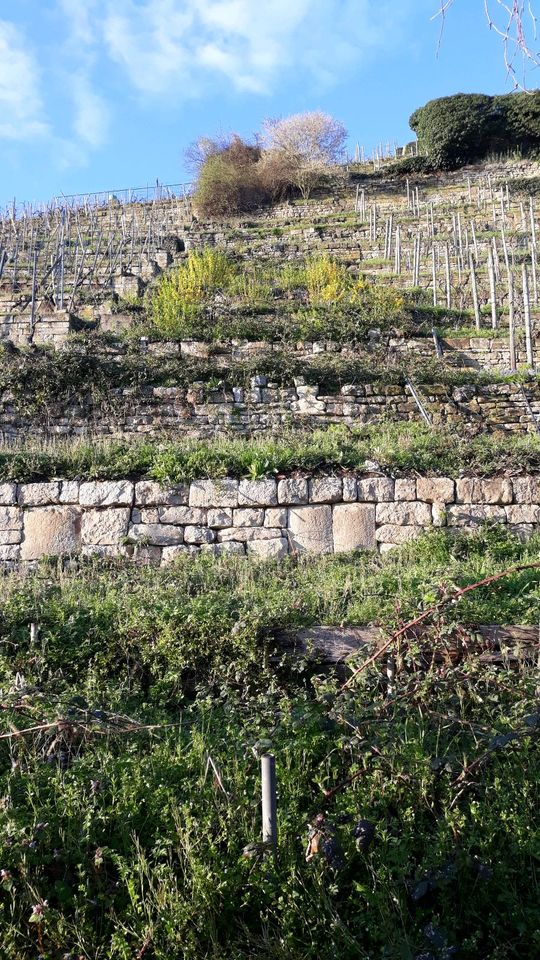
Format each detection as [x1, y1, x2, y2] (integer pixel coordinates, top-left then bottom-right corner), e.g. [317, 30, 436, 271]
[0, 423, 540, 484]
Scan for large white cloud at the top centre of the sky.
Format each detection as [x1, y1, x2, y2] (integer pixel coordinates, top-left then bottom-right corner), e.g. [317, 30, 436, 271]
[99, 0, 408, 99]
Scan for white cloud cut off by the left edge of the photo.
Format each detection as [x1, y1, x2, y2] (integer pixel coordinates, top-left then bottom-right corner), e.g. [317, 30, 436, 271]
[0, 20, 49, 140]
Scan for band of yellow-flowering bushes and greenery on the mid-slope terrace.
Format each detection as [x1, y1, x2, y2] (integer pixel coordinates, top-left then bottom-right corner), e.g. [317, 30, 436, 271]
[149, 249, 421, 343]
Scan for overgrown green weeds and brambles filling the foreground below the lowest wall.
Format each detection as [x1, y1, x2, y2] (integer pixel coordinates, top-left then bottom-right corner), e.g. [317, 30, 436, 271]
[0, 531, 540, 960]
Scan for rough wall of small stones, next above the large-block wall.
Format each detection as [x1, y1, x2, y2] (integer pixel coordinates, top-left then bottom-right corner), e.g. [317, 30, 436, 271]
[0, 376, 540, 443]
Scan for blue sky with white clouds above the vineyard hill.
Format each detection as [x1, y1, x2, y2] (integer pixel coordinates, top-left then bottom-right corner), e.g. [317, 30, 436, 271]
[0, 0, 535, 205]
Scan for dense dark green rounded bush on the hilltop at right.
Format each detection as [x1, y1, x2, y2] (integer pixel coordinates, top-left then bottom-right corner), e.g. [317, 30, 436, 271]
[409, 91, 540, 170]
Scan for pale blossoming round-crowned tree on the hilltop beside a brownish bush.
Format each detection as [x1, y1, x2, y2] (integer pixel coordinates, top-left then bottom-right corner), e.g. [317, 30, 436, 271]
[261, 110, 347, 199]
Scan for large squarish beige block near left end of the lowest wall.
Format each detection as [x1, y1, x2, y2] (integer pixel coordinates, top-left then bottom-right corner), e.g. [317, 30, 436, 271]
[21, 506, 81, 560]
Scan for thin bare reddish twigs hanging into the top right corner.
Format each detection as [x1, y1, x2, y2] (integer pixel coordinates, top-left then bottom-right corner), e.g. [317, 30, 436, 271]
[434, 0, 540, 87]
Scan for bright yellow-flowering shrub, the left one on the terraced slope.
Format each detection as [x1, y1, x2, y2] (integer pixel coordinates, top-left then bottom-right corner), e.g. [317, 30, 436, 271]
[150, 249, 236, 336]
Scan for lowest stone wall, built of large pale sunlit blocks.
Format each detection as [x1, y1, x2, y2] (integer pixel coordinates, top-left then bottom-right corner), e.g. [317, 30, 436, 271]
[0, 474, 540, 565]
